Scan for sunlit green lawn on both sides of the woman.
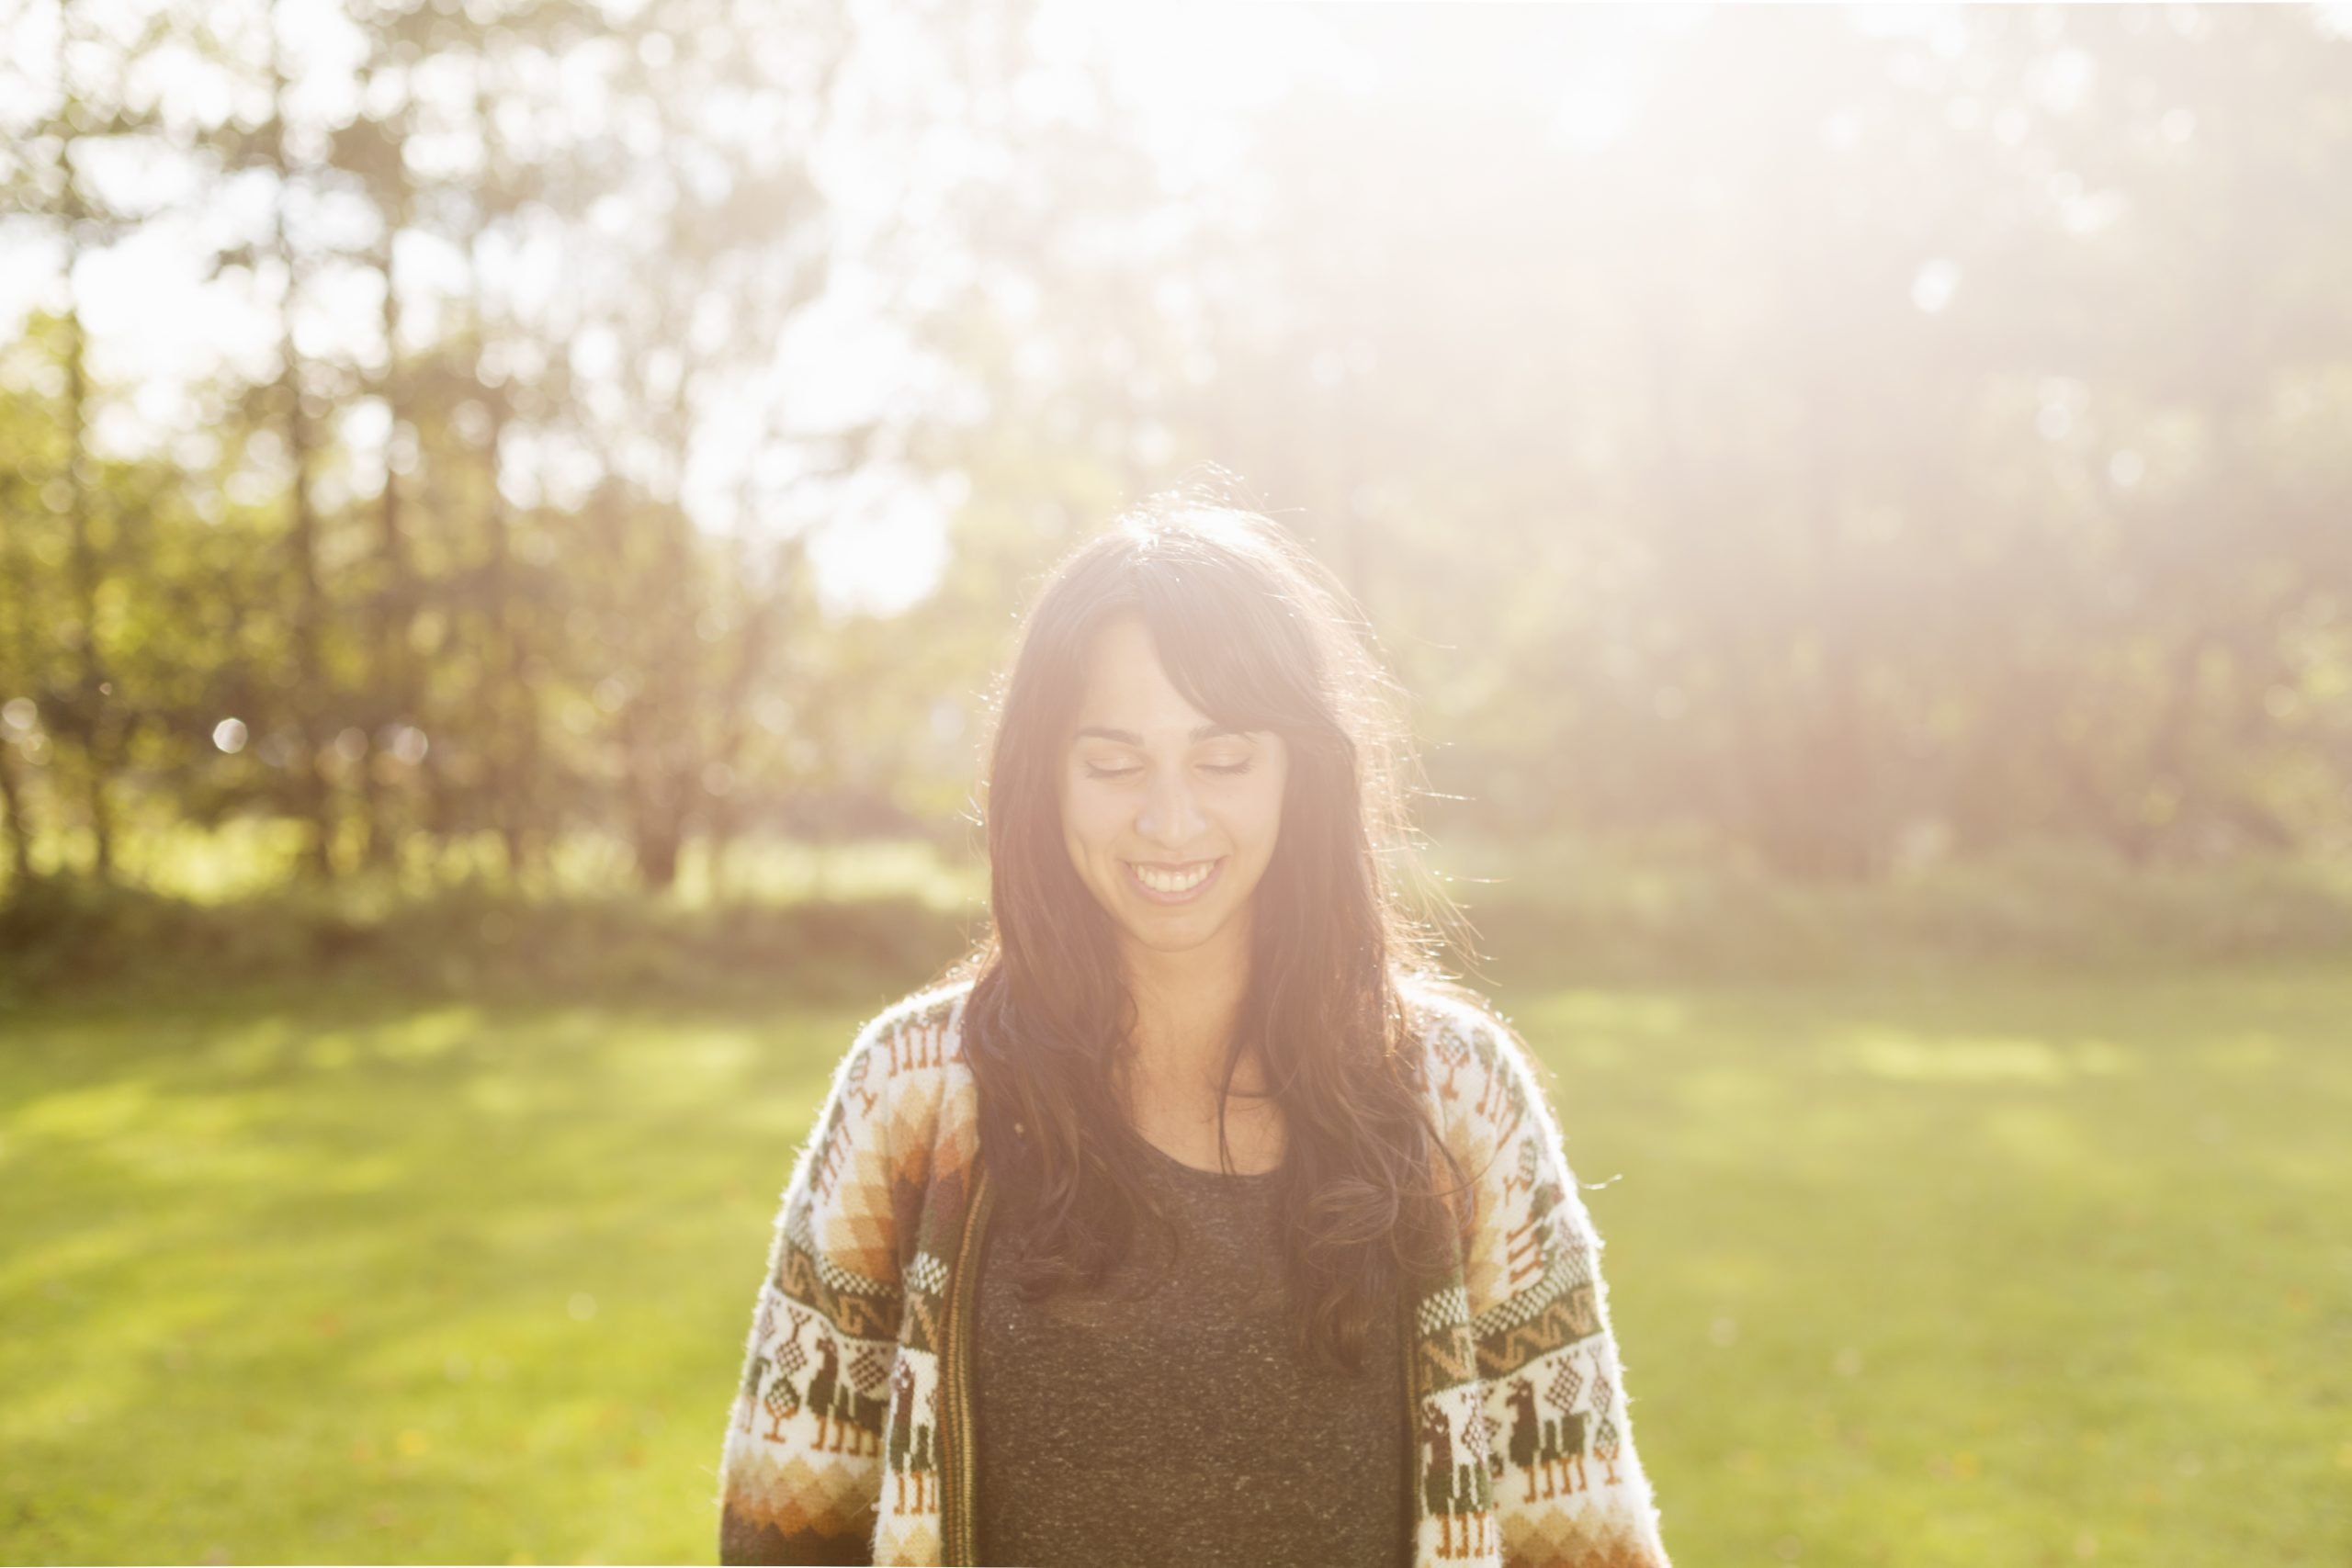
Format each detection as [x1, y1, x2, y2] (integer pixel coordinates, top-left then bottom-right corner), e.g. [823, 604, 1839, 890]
[0, 968, 2352, 1568]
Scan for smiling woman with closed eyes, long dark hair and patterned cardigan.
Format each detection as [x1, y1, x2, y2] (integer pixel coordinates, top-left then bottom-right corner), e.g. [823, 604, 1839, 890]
[719, 501, 1665, 1565]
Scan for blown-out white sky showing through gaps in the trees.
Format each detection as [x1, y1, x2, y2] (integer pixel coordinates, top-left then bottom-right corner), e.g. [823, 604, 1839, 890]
[0, 0, 1778, 611]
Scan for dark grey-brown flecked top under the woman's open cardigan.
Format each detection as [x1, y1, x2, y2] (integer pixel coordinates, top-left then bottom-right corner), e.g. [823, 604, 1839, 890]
[974, 1145, 1411, 1568]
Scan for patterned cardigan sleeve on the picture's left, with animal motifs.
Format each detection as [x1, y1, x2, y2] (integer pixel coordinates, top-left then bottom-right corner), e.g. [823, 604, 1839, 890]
[719, 1013, 903, 1563]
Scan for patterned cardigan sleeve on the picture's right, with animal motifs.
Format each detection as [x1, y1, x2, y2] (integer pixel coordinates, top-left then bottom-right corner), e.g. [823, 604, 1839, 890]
[1442, 1009, 1668, 1568]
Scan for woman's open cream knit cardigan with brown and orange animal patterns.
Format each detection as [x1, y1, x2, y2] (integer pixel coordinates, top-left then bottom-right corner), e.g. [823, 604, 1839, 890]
[719, 983, 1668, 1568]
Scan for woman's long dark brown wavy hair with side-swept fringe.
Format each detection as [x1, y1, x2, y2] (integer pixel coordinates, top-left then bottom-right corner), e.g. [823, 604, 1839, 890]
[941, 493, 1465, 1368]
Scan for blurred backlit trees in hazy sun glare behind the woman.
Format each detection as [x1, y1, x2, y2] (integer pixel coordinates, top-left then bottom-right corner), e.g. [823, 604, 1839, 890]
[0, 0, 2352, 921]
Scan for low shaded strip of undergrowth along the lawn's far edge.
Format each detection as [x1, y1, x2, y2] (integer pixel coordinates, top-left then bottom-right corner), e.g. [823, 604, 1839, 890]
[0, 844, 2352, 1001]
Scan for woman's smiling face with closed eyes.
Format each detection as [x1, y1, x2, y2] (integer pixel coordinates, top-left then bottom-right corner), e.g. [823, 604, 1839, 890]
[1061, 616, 1289, 952]
